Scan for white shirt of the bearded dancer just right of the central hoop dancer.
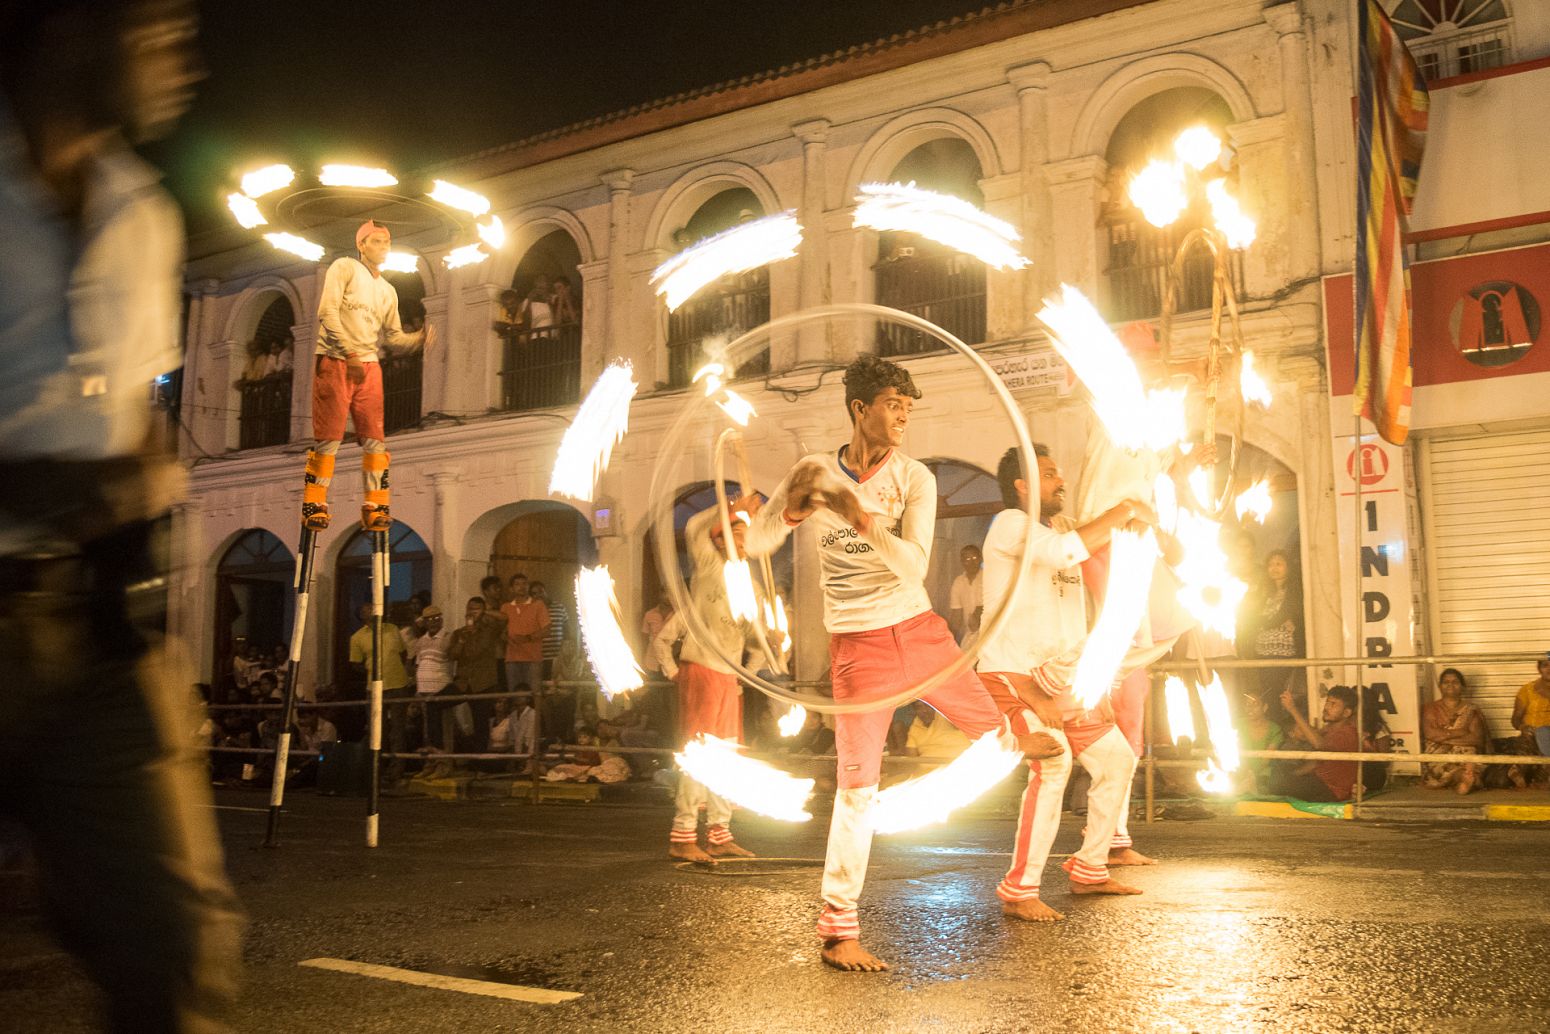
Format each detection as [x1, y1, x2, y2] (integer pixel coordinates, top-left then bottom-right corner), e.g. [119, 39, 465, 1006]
[978, 510, 1088, 674]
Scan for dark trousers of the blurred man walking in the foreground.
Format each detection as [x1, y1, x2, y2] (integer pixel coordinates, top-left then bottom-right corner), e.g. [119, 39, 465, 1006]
[0, 594, 242, 1032]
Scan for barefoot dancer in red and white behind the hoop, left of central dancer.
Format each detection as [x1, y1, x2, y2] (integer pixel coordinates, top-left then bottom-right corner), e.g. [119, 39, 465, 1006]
[651, 495, 760, 862]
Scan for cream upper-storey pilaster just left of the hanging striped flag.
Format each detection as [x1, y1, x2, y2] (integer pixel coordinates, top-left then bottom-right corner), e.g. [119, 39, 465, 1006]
[1263, 0, 1322, 281]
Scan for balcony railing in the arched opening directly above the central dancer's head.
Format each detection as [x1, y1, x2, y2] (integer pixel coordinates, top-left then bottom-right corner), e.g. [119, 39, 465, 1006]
[873, 245, 984, 355]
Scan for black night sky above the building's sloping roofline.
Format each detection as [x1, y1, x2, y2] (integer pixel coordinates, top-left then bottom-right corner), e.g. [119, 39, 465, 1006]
[147, 0, 986, 231]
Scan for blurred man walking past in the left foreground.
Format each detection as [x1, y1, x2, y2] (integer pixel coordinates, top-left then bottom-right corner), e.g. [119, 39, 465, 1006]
[0, 0, 240, 1031]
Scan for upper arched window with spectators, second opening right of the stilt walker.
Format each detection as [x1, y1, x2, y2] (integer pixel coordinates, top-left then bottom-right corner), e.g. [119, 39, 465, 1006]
[494, 229, 581, 411]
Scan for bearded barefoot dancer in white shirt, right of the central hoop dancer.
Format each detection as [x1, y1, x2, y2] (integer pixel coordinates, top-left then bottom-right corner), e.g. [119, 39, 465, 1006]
[978, 445, 1150, 922]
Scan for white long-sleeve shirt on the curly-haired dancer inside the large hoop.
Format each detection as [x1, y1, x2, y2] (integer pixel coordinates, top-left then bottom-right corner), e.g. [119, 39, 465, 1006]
[746, 450, 936, 634]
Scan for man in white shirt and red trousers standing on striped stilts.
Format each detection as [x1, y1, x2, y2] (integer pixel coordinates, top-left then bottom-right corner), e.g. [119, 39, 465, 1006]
[301, 219, 436, 532]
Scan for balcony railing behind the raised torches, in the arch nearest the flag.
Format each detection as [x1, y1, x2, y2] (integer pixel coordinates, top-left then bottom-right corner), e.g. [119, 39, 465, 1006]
[1105, 219, 1243, 322]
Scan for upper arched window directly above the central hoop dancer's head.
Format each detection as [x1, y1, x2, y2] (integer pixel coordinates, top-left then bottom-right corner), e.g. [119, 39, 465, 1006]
[873, 136, 984, 355]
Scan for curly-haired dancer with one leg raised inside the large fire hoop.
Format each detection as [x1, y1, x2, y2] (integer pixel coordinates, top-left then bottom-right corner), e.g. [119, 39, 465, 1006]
[747, 355, 1060, 972]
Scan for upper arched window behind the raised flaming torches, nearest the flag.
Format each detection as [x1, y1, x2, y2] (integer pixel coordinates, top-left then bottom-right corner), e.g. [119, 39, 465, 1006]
[1102, 87, 1243, 322]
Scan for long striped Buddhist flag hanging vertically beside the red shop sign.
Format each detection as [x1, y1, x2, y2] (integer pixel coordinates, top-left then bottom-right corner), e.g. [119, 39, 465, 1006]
[1356, 0, 1429, 445]
